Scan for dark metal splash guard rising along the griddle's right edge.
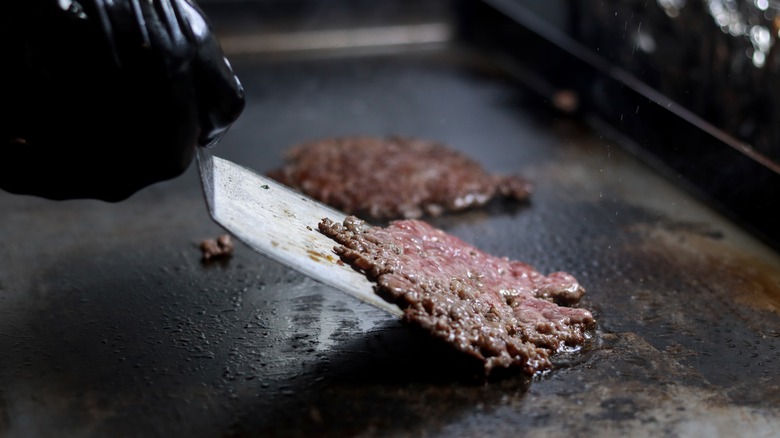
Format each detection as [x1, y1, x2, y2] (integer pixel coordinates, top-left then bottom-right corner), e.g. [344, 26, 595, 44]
[461, 0, 780, 250]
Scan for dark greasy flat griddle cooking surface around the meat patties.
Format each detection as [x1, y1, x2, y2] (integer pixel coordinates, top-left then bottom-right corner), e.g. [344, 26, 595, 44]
[0, 52, 780, 436]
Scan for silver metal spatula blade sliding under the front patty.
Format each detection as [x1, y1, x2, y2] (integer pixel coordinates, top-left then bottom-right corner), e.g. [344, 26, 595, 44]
[198, 148, 401, 316]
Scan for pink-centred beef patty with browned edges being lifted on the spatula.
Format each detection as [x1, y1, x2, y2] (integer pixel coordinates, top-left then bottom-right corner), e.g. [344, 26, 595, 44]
[319, 216, 595, 375]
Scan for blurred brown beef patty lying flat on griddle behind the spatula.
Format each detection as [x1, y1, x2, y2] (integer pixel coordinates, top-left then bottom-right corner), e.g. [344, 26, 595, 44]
[268, 137, 531, 219]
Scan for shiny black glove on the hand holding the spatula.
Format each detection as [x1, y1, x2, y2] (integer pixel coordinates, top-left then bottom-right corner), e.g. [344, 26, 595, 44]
[0, 0, 244, 202]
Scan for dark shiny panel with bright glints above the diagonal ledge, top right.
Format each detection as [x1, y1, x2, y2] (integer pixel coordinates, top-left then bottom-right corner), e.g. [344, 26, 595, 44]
[569, 0, 780, 163]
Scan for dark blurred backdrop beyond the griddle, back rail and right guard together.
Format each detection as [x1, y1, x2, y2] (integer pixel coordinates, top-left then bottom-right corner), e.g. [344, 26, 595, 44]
[199, 0, 780, 245]
